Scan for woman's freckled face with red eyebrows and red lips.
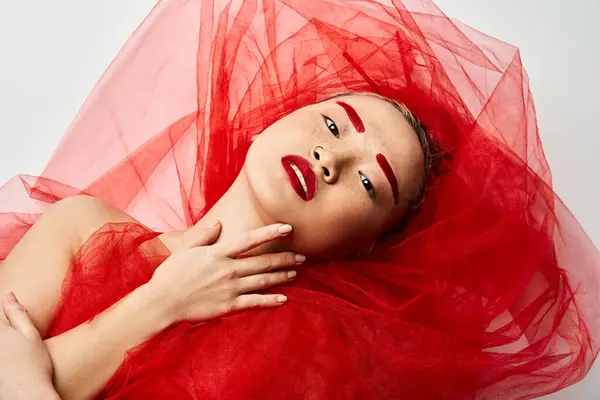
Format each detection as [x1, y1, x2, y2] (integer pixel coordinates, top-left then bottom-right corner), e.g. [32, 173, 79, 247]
[243, 95, 424, 258]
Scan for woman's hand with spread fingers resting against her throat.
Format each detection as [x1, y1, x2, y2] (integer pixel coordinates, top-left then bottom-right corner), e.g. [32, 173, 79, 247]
[146, 224, 305, 323]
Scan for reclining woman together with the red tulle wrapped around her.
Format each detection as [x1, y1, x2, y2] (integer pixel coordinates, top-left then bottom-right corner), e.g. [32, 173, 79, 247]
[2, 0, 600, 398]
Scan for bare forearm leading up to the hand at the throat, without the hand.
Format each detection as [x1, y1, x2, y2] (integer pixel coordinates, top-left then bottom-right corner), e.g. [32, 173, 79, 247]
[45, 285, 170, 399]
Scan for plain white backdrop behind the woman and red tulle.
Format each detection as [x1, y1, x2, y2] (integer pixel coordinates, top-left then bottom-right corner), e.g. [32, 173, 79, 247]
[0, 0, 600, 400]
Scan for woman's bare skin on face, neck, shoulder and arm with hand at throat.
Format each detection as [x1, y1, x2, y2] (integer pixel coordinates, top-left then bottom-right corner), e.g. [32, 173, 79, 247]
[0, 95, 423, 399]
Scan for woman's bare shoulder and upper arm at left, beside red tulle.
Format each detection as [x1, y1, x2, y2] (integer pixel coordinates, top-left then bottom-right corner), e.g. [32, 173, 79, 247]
[0, 196, 145, 336]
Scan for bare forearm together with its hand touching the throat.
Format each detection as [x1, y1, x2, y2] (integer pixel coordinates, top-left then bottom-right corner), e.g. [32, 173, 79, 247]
[46, 225, 304, 399]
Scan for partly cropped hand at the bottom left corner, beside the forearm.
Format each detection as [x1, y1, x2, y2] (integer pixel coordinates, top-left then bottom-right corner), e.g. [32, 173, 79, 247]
[0, 292, 59, 399]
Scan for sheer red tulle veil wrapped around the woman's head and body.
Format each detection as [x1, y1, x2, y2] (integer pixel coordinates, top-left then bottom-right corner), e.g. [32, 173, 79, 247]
[0, 0, 600, 399]
